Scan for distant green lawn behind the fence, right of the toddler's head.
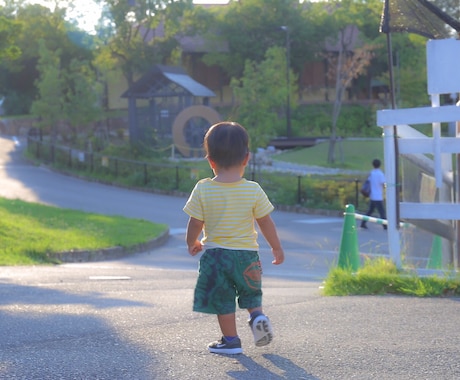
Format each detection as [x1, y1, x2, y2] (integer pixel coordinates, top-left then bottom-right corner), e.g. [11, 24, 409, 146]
[273, 139, 385, 171]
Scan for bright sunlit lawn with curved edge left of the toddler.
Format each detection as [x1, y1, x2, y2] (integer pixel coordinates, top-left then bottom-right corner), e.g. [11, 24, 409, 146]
[0, 198, 168, 265]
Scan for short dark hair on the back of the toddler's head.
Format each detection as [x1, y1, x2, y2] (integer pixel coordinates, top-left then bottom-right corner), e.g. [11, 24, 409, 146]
[203, 121, 249, 169]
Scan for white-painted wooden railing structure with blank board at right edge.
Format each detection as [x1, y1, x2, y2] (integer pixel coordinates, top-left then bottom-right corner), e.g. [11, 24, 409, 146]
[377, 39, 460, 269]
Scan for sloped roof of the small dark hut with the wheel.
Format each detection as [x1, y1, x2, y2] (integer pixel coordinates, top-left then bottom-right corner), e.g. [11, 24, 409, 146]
[121, 65, 216, 99]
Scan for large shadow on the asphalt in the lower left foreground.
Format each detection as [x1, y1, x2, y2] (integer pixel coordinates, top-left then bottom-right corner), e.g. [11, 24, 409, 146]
[0, 283, 156, 380]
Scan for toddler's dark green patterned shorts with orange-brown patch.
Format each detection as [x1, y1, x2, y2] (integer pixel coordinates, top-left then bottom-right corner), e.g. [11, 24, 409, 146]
[193, 248, 262, 315]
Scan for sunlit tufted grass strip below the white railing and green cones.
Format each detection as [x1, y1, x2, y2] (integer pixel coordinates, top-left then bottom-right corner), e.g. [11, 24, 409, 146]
[323, 258, 460, 297]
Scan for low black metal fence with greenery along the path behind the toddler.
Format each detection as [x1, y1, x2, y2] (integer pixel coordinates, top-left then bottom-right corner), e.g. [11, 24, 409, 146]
[27, 137, 362, 211]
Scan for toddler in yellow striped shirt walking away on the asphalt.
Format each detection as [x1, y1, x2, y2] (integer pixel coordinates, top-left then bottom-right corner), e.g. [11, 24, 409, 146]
[184, 122, 284, 354]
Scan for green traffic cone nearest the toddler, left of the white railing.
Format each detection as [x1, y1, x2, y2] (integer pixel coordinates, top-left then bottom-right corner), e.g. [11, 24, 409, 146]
[338, 205, 360, 271]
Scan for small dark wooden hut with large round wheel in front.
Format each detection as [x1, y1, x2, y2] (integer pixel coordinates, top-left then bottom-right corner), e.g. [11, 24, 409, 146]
[121, 65, 220, 153]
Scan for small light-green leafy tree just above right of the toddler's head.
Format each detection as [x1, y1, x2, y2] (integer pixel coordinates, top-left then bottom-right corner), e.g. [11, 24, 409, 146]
[231, 47, 297, 162]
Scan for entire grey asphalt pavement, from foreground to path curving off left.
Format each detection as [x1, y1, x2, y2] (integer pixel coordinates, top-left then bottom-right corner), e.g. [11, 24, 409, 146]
[0, 138, 460, 380]
